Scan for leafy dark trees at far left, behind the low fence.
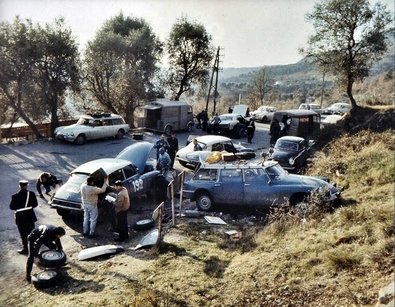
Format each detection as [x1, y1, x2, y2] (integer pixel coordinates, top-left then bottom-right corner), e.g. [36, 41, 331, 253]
[0, 18, 79, 138]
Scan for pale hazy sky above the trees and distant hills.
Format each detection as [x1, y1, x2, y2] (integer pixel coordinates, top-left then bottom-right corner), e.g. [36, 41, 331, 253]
[0, 0, 394, 67]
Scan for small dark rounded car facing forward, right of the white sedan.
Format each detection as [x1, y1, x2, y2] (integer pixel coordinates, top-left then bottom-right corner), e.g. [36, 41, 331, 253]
[266, 136, 311, 172]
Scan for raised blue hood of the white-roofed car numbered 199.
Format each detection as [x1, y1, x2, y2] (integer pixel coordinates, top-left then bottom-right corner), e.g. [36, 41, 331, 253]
[115, 141, 154, 175]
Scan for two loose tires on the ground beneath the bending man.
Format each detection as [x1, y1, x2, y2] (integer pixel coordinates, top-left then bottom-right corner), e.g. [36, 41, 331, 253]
[32, 250, 66, 289]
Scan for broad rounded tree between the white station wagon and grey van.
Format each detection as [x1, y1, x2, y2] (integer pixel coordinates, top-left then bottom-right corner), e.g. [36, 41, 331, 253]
[84, 14, 162, 126]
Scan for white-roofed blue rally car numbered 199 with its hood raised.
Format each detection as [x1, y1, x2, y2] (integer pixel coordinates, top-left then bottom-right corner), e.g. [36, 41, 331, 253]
[49, 142, 163, 216]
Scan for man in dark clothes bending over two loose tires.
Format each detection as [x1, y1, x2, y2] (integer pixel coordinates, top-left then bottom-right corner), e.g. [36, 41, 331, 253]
[26, 225, 66, 283]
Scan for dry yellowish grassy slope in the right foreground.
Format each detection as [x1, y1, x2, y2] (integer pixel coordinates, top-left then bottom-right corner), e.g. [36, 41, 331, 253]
[137, 131, 395, 306]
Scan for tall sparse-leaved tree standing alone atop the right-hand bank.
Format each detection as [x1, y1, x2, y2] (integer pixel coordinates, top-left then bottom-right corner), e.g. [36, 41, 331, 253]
[301, 0, 392, 109]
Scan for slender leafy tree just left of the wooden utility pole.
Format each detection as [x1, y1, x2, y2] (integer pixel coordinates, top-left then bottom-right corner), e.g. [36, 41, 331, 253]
[167, 17, 214, 100]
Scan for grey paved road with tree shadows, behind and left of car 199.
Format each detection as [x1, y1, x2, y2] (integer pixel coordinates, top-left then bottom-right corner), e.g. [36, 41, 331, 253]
[0, 123, 269, 278]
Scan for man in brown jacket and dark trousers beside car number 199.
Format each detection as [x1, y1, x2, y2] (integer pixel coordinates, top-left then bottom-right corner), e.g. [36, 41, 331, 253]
[114, 180, 130, 242]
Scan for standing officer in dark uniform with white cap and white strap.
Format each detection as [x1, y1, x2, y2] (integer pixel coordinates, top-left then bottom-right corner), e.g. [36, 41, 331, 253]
[10, 180, 38, 255]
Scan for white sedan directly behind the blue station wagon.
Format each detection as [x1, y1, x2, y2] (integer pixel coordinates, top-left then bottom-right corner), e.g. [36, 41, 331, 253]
[176, 135, 256, 169]
